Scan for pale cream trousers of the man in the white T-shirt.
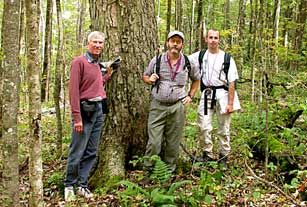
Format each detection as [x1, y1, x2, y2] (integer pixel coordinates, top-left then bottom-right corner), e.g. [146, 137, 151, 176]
[198, 93, 231, 158]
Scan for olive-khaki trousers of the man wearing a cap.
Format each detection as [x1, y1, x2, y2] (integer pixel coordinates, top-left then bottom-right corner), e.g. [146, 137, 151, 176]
[144, 100, 185, 172]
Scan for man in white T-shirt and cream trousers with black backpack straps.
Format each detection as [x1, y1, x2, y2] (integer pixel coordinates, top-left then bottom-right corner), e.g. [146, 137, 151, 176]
[189, 29, 240, 168]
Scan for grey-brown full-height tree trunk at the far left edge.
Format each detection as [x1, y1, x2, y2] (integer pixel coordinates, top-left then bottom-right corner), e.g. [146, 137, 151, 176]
[0, 0, 20, 206]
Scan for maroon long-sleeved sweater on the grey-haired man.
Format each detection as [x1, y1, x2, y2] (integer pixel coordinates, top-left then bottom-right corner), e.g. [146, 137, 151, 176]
[69, 55, 110, 122]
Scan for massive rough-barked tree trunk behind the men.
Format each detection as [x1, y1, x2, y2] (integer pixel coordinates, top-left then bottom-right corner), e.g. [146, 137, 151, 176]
[91, 0, 157, 185]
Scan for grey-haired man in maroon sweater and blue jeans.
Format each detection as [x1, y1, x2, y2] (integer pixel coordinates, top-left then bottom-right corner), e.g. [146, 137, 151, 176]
[64, 31, 113, 201]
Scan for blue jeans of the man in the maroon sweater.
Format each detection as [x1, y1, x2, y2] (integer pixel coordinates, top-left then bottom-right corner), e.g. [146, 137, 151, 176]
[64, 102, 104, 187]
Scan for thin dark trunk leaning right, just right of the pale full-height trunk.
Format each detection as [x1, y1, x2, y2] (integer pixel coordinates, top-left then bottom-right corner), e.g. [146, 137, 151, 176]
[41, 0, 53, 101]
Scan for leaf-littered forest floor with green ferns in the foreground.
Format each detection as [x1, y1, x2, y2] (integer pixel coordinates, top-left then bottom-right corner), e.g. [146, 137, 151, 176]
[20, 151, 305, 207]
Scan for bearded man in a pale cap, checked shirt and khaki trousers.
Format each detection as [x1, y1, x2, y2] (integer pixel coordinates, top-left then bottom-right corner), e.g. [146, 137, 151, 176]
[143, 31, 200, 172]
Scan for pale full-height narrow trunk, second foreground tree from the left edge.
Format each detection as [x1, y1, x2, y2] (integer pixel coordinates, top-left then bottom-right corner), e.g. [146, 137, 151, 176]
[26, 0, 43, 207]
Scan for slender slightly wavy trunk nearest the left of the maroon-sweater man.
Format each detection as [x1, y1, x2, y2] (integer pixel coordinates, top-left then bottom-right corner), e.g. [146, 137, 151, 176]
[53, 0, 64, 158]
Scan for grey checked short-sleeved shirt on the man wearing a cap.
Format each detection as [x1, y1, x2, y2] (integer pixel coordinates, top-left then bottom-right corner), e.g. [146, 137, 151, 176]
[144, 53, 200, 103]
